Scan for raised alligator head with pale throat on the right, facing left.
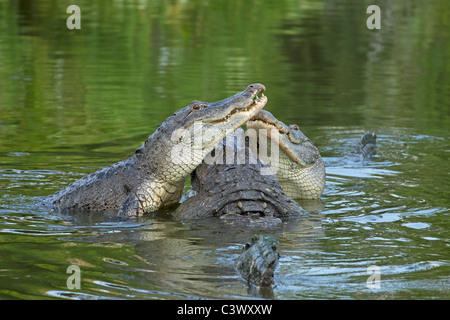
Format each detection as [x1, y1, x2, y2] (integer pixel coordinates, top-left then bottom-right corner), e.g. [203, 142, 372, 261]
[247, 110, 325, 199]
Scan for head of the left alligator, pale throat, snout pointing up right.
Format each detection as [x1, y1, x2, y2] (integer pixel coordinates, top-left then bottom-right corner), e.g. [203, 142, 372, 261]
[142, 84, 267, 181]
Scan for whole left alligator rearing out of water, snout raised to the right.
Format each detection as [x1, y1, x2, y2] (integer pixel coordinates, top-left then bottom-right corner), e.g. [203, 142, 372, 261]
[45, 83, 267, 218]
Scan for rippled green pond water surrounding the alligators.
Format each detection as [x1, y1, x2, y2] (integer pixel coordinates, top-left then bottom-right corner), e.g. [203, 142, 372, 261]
[0, 0, 450, 299]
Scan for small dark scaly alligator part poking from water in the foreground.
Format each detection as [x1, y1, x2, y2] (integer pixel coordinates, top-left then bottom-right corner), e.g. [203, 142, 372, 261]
[236, 235, 280, 288]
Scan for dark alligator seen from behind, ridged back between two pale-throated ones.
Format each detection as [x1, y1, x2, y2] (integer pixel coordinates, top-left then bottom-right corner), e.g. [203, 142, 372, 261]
[174, 128, 305, 227]
